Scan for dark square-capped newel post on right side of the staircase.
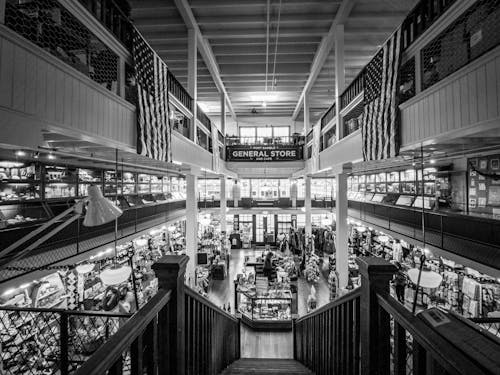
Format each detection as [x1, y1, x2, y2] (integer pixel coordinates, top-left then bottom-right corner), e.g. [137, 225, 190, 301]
[357, 257, 397, 375]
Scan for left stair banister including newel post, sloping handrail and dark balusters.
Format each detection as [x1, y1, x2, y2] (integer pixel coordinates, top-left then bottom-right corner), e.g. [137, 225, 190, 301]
[75, 255, 240, 375]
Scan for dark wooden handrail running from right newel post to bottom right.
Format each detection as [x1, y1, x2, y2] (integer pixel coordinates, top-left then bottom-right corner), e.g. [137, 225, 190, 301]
[377, 295, 492, 375]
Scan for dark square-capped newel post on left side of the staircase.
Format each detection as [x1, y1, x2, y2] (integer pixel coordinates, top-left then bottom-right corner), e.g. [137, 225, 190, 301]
[153, 255, 189, 375]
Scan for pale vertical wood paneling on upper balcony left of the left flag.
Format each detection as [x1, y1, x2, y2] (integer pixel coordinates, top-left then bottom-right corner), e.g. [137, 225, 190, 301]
[0, 26, 136, 148]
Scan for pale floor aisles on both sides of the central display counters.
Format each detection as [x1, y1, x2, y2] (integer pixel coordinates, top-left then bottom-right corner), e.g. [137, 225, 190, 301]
[208, 248, 330, 316]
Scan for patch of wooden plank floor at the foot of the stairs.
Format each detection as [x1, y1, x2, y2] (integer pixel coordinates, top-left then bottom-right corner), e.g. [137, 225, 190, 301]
[241, 325, 293, 359]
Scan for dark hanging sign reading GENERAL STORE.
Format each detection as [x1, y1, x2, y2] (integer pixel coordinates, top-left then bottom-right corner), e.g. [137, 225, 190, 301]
[226, 146, 302, 161]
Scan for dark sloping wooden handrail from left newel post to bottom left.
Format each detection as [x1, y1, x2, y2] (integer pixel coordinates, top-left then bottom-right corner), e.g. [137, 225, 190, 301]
[75, 289, 171, 375]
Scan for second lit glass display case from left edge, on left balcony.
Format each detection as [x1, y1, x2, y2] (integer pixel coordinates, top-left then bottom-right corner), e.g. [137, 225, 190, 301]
[44, 166, 78, 199]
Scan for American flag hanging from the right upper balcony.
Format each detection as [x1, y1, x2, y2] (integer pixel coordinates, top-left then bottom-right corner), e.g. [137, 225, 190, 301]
[361, 29, 401, 160]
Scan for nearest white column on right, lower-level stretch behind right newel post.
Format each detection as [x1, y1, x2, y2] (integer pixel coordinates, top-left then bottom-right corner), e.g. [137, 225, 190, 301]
[335, 173, 349, 288]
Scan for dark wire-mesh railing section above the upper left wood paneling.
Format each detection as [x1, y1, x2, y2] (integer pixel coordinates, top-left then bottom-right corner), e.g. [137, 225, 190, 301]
[5, 0, 119, 94]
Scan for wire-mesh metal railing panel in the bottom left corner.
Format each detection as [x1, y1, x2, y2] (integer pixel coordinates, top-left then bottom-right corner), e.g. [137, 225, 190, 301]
[0, 307, 131, 375]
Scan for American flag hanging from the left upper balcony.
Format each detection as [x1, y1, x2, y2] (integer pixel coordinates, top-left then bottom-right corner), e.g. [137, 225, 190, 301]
[132, 30, 172, 161]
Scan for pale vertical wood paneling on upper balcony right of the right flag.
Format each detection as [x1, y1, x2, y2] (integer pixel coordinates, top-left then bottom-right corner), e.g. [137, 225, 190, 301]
[401, 47, 500, 147]
